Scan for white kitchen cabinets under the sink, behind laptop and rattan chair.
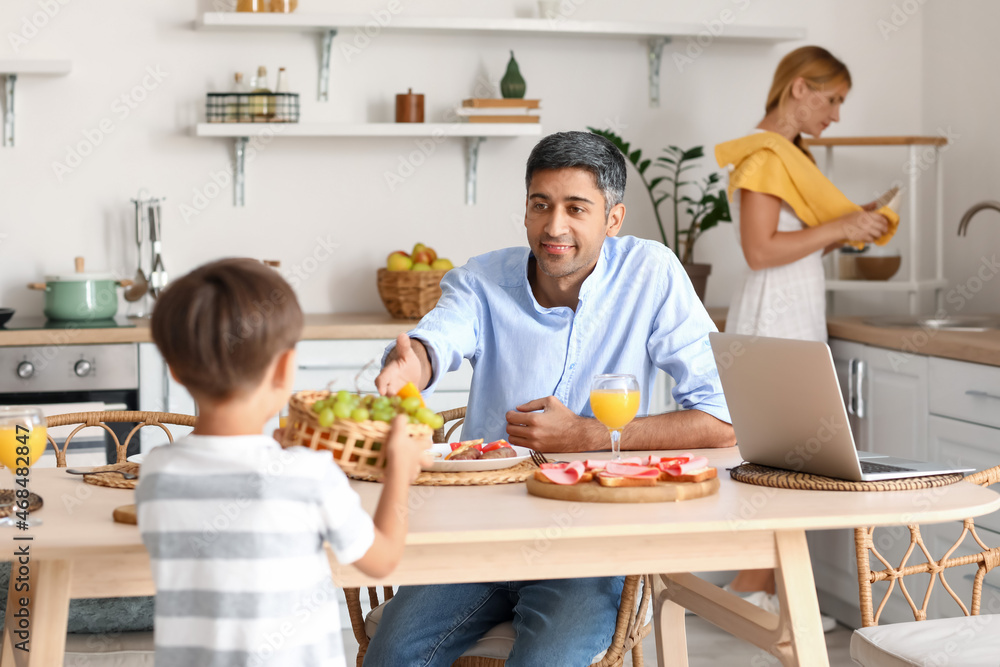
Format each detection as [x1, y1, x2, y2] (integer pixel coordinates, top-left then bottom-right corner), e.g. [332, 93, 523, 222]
[809, 339, 1000, 625]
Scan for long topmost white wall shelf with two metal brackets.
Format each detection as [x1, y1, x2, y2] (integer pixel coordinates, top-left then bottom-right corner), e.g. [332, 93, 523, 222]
[197, 11, 806, 107]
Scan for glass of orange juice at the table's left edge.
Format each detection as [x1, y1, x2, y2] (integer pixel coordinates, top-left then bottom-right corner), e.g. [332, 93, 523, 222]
[0, 405, 46, 526]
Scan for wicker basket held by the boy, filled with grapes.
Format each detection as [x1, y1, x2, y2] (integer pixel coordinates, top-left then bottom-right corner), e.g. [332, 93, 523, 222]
[281, 391, 433, 477]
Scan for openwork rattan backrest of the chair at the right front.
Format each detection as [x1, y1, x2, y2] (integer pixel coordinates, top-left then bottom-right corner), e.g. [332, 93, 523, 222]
[854, 466, 1000, 627]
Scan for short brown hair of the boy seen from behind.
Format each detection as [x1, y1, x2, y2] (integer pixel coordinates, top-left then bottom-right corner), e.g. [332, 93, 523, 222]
[150, 258, 303, 400]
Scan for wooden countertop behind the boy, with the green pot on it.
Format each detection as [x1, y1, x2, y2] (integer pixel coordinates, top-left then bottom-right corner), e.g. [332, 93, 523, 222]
[0, 313, 417, 346]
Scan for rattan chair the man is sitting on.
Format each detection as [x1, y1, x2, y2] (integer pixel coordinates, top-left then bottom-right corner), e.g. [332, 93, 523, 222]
[344, 408, 652, 667]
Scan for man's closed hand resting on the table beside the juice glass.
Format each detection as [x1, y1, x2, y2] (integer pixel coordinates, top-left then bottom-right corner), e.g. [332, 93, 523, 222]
[507, 396, 610, 452]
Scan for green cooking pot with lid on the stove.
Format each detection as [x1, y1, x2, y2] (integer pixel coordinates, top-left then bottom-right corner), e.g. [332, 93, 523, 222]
[28, 271, 132, 321]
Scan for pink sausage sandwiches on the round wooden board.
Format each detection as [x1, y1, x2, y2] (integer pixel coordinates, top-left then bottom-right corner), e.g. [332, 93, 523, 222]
[534, 453, 717, 487]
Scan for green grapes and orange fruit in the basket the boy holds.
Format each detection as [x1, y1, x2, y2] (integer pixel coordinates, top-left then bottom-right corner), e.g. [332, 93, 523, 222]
[312, 384, 444, 429]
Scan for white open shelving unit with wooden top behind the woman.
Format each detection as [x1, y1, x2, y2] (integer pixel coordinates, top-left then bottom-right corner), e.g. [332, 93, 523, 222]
[805, 135, 948, 315]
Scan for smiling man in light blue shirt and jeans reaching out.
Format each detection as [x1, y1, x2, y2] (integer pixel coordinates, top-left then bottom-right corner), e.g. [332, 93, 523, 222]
[365, 132, 735, 667]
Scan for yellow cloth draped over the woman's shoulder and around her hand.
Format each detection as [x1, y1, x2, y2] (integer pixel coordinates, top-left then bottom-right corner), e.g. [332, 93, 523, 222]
[715, 132, 899, 248]
